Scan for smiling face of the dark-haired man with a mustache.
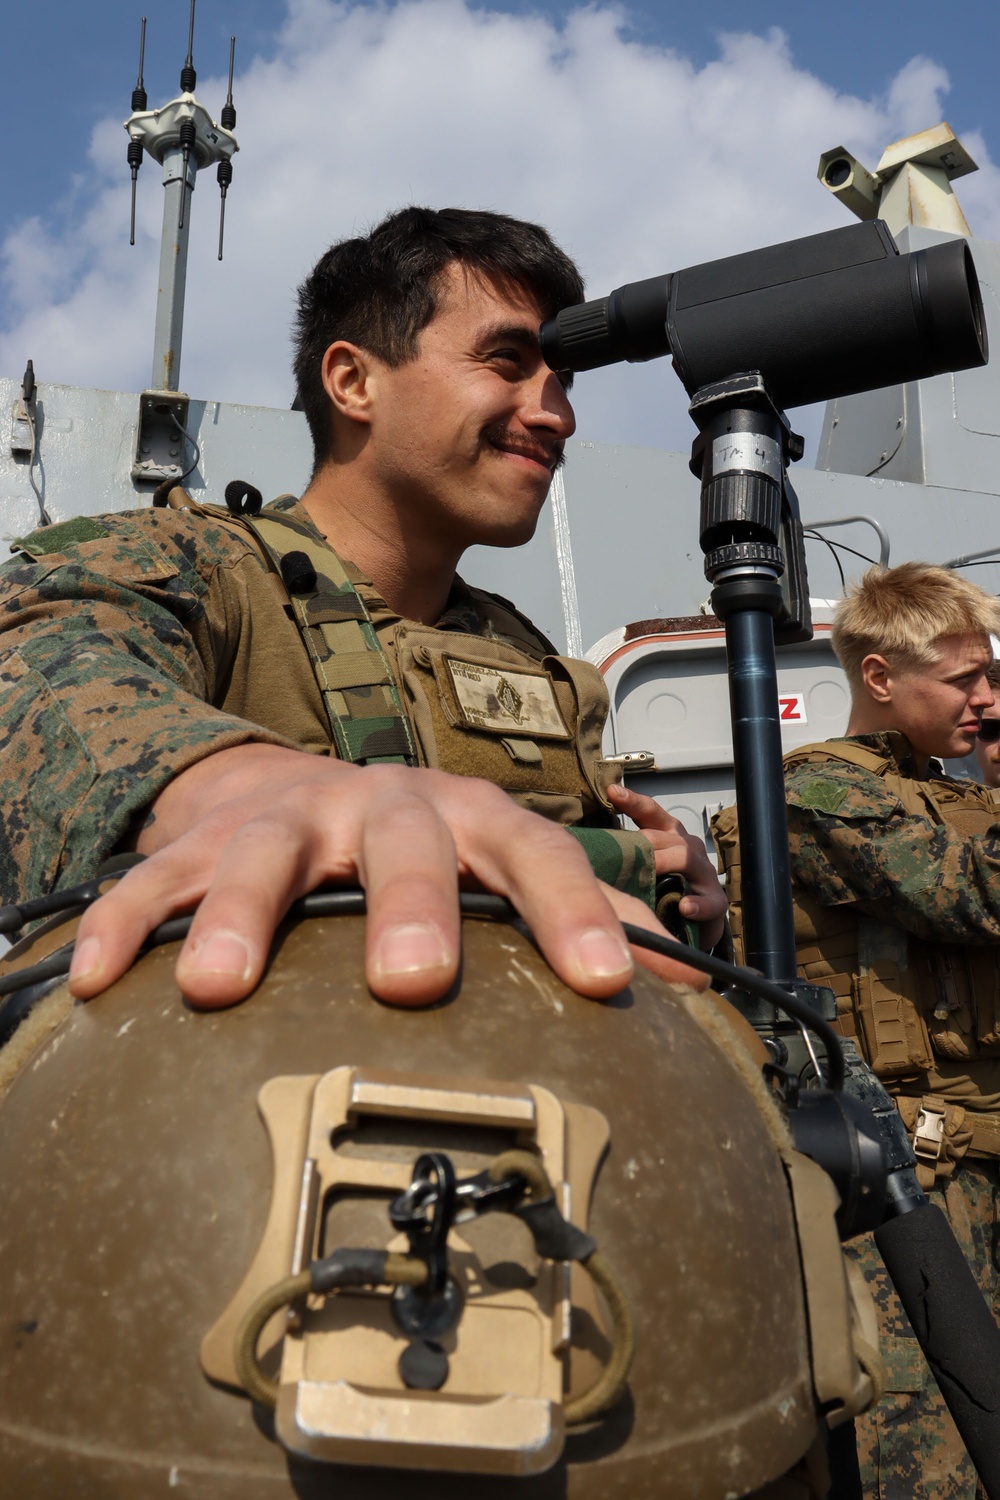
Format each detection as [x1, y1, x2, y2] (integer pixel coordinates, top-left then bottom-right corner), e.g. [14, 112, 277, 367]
[367, 263, 576, 557]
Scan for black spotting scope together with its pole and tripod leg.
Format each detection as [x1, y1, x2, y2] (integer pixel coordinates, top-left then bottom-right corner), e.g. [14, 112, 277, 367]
[538, 219, 1000, 1500]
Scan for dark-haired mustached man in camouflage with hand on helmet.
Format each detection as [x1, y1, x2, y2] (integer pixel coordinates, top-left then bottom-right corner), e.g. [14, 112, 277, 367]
[0, 209, 724, 1007]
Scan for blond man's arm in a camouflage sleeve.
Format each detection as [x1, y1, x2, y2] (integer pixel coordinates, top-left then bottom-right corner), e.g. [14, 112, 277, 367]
[786, 765, 1000, 944]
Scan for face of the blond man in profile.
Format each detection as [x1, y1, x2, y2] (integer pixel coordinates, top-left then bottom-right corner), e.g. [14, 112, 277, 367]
[853, 635, 994, 768]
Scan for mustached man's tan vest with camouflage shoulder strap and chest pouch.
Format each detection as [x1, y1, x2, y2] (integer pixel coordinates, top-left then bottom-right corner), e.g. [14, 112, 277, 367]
[235, 510, 621, 828]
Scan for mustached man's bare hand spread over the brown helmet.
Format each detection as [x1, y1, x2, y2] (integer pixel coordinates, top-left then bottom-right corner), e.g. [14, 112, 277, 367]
[70, 746, 705, 1008]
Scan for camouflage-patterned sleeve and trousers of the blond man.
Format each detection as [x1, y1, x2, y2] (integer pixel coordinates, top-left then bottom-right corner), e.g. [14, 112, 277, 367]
[786, 732, 1000, 1500]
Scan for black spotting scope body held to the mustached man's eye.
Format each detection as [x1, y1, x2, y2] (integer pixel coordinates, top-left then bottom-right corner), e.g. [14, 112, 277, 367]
[538, 219, 988, 407]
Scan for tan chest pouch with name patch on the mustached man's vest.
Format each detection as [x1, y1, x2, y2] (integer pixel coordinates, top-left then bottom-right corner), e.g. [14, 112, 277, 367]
[396, 623, 621, 822]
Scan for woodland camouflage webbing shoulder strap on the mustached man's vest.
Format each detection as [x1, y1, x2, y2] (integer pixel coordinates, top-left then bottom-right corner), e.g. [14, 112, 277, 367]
[241, 512, 417, 765]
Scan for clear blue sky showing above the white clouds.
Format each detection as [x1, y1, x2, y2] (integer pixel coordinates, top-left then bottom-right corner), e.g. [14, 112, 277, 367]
[0, 0, 1000, 249]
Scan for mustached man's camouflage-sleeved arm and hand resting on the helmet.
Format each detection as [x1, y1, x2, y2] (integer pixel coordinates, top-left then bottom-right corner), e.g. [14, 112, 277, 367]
[0, 512, 703, 1005]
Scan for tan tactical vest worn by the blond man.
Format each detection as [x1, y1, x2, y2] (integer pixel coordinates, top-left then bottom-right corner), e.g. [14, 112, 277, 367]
[712, 741, 1000, 1128]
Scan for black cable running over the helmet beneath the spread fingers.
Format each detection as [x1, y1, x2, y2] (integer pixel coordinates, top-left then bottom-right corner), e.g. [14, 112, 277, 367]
[0, 876, 844, 1089]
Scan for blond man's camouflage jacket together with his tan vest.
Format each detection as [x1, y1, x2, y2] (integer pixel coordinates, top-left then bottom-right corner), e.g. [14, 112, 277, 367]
[714, 732, 1000, 1110]
